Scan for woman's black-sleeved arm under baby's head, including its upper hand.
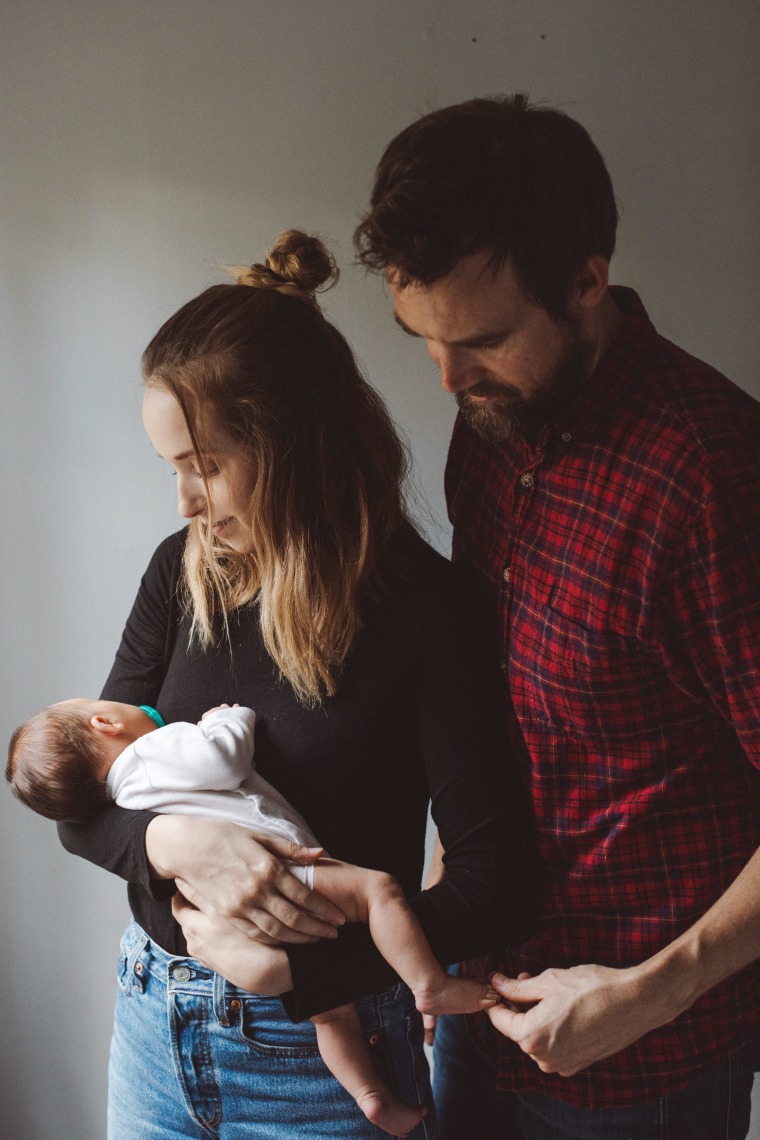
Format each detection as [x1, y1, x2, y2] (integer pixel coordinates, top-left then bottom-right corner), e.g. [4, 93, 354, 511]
[59, 531, 343, 942]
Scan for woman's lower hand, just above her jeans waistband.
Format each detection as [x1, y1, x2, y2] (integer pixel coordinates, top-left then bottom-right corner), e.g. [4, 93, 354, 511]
[172, 895, 293, 996]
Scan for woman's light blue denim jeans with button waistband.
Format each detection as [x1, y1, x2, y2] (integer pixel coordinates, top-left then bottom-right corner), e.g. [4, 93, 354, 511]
[108, 923, 439, 1140]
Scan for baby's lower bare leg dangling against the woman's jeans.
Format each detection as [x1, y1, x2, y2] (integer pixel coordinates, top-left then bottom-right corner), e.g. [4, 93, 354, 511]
[311, 1005, 427, 1137]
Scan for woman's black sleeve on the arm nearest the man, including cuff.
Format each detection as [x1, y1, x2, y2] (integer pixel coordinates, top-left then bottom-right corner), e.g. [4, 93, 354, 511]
[283, 577, 541, 1020]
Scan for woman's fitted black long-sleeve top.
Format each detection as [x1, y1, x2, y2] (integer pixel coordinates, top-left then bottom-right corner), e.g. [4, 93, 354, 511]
[59, 524, 539, 1018]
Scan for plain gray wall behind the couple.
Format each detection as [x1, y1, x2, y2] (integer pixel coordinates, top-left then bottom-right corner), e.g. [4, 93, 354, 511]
[0, 0, 760, 1140]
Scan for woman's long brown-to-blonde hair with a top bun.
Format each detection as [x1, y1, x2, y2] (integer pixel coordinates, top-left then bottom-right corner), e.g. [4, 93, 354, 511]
[142, 230, 407, 702]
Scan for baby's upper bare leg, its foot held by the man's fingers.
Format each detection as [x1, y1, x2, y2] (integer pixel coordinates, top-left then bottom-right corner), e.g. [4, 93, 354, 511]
[314, 858, 499, 1013]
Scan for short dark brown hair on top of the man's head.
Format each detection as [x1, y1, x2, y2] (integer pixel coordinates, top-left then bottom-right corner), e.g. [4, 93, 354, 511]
[354, 95, 618, 319]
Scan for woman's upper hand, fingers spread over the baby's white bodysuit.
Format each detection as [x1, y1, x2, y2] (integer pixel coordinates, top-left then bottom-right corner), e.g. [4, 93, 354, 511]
[145, 815, 345, 945]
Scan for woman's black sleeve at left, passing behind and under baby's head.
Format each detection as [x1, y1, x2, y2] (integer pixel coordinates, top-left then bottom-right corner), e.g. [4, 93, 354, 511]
[58, 532, 183, 899]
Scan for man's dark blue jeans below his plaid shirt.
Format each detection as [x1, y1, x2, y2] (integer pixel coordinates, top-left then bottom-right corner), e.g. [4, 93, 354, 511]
[433, 1016, 754, 1140]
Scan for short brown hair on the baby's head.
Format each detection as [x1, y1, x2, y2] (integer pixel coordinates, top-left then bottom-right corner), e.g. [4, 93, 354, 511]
[6, 708, 109, 823]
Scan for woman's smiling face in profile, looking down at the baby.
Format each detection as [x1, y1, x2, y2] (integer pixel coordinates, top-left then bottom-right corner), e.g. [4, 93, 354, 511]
[142, 388, 256, 554]
